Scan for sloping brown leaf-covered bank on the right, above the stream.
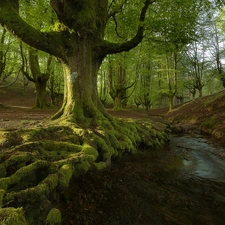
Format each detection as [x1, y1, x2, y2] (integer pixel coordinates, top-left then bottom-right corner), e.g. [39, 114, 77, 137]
[166, 91, 225, 139]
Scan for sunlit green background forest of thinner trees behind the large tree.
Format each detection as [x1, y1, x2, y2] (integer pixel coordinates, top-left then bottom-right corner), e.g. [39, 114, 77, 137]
[0, 1, 225, 110]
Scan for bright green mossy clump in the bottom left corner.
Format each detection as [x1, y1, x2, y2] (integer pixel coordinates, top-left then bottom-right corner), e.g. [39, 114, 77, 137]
[0, 208, 27, 225]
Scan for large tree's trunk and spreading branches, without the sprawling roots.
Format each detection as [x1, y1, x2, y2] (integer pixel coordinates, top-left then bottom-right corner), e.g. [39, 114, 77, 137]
[0, 0, 154, 123]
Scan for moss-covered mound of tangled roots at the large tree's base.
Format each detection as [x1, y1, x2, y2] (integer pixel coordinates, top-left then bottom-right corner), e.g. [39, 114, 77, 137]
[0, 118, 168, 225]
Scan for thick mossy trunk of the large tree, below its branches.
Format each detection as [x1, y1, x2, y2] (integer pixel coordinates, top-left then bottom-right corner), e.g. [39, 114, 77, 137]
[53, 42, 106, 124]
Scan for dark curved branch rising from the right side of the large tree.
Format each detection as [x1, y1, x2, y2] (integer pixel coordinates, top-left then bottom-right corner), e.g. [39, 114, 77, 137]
[101, 0, 155, 57]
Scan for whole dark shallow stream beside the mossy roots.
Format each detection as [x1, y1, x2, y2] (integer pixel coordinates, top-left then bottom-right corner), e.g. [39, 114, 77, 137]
[61, 134, 225, 225]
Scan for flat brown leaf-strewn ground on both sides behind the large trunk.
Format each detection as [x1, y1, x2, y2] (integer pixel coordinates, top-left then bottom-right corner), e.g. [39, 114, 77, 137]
[0, 85, 167, 130]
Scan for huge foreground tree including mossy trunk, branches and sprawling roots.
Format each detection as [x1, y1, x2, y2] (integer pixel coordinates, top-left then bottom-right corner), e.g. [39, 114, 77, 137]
[0, 0, 224, 225]
